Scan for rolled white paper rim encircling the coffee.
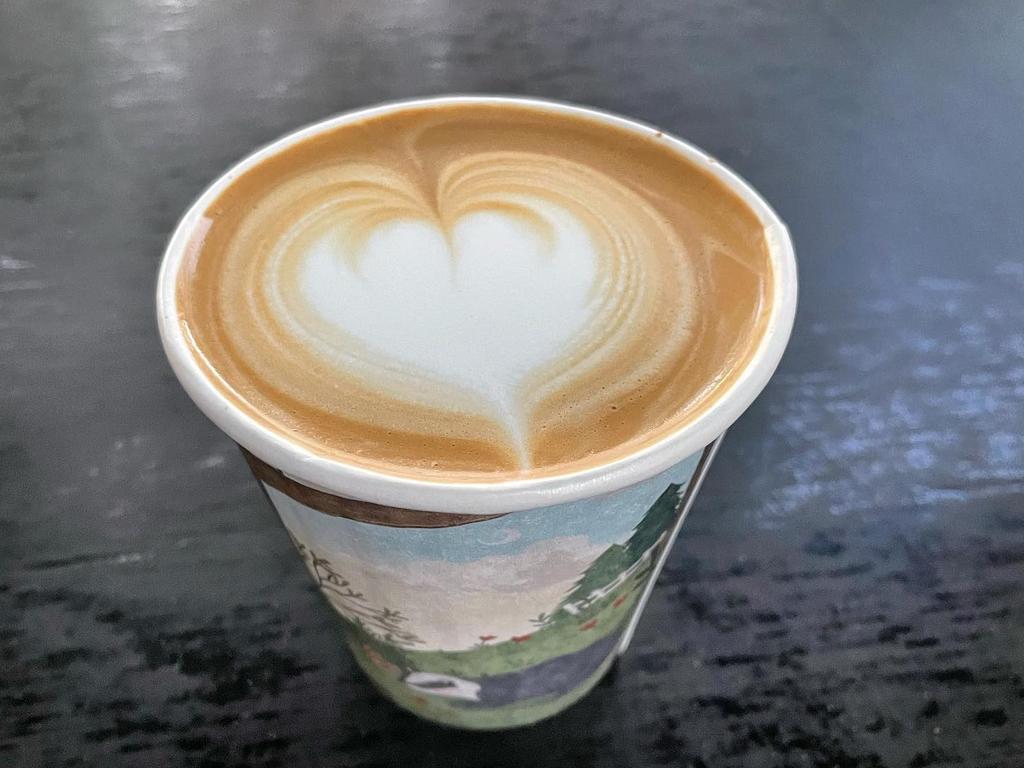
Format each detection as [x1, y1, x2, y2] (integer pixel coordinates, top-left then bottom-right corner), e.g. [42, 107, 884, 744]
[157, 95, 797, 515]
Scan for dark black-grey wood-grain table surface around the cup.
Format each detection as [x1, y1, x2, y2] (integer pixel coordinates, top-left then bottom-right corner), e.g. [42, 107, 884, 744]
[0, 0, 1024, 768]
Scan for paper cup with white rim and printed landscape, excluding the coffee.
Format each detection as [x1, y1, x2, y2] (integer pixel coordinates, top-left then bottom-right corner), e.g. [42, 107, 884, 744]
[157, 96, 797, 728]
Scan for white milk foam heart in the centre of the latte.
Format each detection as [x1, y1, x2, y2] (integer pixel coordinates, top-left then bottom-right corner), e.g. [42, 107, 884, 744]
[300, 200, 597, 452]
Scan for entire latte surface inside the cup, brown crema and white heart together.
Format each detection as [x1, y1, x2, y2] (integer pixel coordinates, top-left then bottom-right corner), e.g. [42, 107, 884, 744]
[177, 103, 772, 481]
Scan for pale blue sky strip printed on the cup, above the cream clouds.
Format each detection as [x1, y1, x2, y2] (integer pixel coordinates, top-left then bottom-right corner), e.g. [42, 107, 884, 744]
[288, 454, 700, 562]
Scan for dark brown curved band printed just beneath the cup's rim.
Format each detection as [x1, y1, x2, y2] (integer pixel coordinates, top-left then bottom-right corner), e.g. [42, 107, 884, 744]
[239, 445, 504, 528]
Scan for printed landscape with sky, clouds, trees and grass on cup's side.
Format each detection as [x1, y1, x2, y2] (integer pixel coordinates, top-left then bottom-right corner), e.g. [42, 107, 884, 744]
[271, 459, 696, 728]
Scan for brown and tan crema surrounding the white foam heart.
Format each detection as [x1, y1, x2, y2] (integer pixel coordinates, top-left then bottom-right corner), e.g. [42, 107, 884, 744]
[177, 102, 773, 482]
